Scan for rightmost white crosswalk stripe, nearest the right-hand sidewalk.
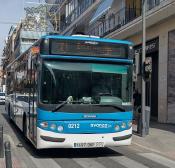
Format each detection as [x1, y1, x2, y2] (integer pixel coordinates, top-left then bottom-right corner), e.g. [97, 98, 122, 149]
[138, 153, 175, 168]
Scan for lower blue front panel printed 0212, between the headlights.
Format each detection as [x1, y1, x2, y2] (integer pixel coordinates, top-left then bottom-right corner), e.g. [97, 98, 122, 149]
[37, 120, 131, 134]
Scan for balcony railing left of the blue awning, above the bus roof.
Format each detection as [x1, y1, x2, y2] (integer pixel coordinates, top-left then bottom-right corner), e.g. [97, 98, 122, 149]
[60, 0, 95, 31]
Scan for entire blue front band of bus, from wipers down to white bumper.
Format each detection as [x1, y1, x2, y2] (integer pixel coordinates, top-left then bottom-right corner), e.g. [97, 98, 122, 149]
[37, 108, 132, 134]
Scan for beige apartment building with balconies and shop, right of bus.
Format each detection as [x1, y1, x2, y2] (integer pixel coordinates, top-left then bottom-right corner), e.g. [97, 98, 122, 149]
[55, 0, 175, 123]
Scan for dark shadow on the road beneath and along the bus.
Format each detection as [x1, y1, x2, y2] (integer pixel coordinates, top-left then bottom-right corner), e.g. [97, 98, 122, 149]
[2, 113, 122, 158]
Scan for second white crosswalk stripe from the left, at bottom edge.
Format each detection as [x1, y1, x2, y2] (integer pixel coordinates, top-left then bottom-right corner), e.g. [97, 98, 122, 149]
[73, 158, 105, 168]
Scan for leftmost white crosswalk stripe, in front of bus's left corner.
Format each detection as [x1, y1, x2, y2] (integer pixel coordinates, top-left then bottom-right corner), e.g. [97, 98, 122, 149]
[30, 156, 61, 168]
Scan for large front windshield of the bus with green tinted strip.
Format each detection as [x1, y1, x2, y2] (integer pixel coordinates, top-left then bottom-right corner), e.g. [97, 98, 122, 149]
[40, 60, 132, 105]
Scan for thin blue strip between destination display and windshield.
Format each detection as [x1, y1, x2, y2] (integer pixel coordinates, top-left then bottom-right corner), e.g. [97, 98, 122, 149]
[41, 55, 133, 64]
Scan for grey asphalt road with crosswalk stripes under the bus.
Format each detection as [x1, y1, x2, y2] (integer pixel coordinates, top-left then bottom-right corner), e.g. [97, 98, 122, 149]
[0, 105, 175, 168]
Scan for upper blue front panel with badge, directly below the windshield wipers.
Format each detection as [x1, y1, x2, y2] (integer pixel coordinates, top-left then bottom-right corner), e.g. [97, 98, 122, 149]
[37, 108, 133, 121]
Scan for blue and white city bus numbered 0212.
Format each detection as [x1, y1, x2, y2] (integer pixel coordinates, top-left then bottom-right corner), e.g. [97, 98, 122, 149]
[5, 35, 133, 149]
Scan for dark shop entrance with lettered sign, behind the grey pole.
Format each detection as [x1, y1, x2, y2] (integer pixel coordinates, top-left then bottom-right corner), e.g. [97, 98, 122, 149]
[134, 38, 159, 121]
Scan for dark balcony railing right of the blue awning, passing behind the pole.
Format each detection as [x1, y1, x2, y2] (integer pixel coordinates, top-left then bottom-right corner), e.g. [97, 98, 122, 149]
[88, 0, 167, 37]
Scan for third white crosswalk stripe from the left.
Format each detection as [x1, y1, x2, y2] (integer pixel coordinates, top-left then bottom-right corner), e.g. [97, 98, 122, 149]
[109, 156, 148, 168]
